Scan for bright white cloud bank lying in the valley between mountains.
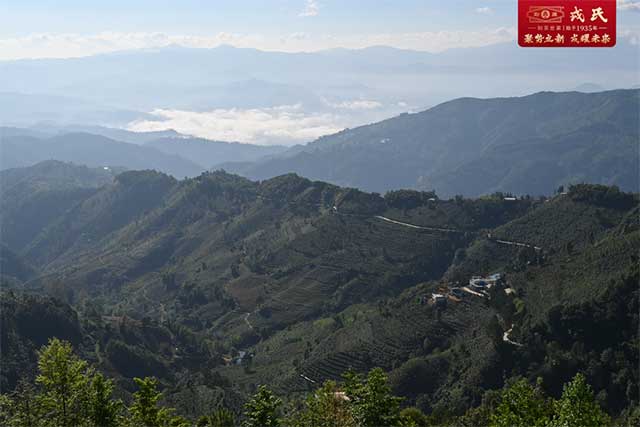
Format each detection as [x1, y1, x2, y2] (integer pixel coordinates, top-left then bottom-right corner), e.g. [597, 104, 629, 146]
[127, 105, 345, 145]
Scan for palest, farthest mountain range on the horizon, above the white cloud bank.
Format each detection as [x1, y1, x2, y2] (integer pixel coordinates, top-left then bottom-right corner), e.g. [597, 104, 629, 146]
[0, 39, 639, 111]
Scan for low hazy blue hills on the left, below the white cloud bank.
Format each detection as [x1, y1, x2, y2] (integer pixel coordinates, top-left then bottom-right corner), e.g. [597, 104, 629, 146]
[0, 130, 285, 178]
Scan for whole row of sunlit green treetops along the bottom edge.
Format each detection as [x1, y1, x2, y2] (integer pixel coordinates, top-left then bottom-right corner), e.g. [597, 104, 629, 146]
[0, 338, 620, 427]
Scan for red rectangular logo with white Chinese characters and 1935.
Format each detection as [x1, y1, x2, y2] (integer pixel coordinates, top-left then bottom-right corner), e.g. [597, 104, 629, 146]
[518, 0, 616, 47]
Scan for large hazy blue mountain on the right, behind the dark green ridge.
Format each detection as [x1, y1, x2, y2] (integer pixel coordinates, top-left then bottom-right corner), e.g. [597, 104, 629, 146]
[223, 90, 640, 196]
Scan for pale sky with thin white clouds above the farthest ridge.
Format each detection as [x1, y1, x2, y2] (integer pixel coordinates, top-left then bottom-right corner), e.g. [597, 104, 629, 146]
[0, 0, 640, 59]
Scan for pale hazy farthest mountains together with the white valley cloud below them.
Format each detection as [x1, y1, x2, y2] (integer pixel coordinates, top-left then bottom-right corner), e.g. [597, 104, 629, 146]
[0, 42, 639, 145]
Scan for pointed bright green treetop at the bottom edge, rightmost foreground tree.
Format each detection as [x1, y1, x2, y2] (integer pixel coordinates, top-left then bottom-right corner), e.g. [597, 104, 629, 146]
[550, 374, 610, 427]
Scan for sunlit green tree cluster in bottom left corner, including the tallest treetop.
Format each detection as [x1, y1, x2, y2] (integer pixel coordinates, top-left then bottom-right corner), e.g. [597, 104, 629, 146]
[0, 338, 192, 427]
